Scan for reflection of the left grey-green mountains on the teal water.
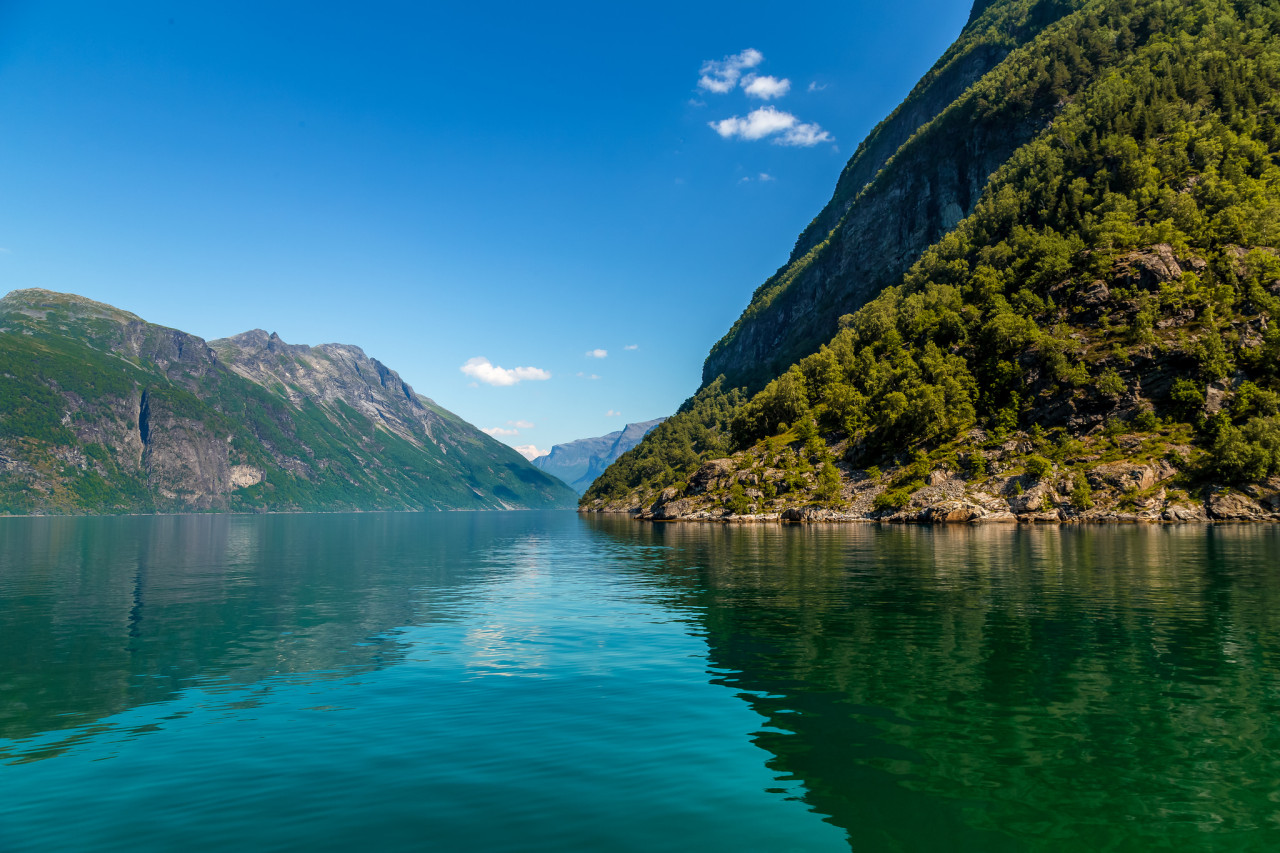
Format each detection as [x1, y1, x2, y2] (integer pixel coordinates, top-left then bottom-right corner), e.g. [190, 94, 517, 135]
[0, 514, 540, 758]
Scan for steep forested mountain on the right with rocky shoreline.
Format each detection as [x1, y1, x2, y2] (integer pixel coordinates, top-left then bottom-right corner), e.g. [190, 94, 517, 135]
[580, 0, 1280, 521]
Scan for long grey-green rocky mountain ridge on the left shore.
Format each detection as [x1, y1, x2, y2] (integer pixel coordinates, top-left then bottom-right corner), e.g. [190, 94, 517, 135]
[0, 289, 573, 514]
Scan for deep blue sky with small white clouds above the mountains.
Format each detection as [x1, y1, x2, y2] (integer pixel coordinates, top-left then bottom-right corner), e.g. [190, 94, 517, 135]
[0, 0, 969, 453]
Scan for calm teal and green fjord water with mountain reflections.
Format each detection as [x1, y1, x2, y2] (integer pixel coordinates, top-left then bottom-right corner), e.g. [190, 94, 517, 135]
[0, 512, 1280, 853]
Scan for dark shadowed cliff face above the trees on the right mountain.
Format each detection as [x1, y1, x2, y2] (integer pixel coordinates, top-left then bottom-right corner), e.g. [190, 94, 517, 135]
[703, 3, 1079, 391]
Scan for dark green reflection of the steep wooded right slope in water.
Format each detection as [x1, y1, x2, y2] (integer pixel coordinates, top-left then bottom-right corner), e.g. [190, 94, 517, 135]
[590, 519, 1280, 850]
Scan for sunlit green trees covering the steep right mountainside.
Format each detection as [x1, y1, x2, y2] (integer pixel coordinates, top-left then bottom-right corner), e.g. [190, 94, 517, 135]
[585, 0, 1280, 507]
